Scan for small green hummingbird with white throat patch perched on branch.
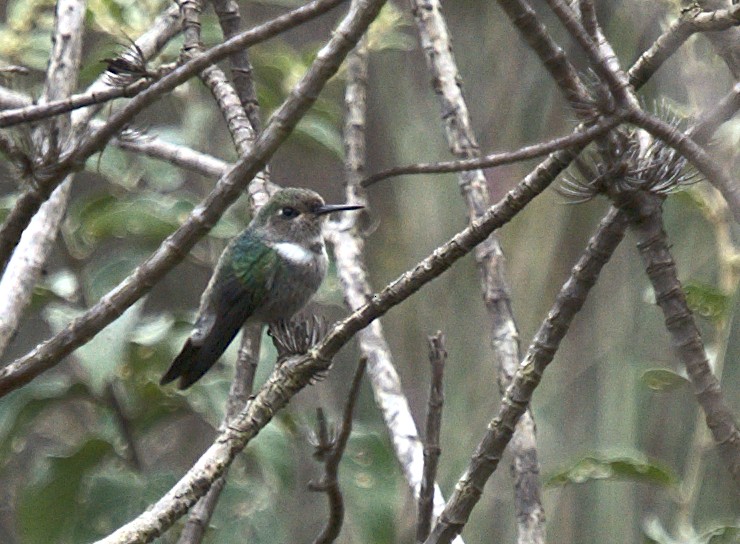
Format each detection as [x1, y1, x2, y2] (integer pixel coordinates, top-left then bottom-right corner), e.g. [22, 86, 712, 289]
[160, 188, 362, 389]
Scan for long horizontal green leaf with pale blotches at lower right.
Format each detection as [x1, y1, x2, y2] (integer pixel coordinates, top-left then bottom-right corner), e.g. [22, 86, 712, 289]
[546, 457, 677, 487]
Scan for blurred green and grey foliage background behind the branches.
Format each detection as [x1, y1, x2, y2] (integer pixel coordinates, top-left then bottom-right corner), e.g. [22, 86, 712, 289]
[0, 0, 740, 544]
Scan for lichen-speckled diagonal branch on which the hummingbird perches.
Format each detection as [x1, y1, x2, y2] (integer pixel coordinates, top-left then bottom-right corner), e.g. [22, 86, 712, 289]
[92, 137, 568, 544]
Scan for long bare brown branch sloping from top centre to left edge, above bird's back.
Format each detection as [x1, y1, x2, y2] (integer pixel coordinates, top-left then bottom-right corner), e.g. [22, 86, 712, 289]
[0, 0, 382, 396]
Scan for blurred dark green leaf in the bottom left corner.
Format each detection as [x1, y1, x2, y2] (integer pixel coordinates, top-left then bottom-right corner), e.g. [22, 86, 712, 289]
[18, 439, 113, 544]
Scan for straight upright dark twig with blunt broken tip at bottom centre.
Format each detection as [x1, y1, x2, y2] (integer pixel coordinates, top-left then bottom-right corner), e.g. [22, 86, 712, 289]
[416, 331, 447, 542]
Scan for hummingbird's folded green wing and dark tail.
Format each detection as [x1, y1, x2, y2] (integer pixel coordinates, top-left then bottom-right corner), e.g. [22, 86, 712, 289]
[160, 240, 278, 389]
